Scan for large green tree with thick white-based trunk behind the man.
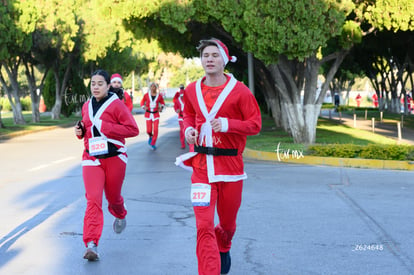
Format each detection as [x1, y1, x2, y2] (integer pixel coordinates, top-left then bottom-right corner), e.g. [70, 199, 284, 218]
[119, 0, 413, 146]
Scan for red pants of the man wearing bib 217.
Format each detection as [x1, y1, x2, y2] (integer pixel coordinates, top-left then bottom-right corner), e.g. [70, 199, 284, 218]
[191, 168, 243, 275]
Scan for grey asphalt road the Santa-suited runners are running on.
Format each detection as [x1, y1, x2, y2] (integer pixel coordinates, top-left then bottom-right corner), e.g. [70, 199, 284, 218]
[0, 109, 414, 275]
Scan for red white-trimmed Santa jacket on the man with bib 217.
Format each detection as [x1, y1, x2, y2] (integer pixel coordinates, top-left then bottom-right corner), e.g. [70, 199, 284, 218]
[176, 75, 262, 182]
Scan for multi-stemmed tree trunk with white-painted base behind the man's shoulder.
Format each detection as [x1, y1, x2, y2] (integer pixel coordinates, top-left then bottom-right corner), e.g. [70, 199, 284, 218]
[262, 50, 348, 144]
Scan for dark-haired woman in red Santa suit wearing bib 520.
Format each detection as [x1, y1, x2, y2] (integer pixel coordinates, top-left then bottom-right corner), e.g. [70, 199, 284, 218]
[75, 70, 139, 261]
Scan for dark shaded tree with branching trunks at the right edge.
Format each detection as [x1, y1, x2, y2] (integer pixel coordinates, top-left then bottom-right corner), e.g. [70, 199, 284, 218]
[353, 30, 414, 114]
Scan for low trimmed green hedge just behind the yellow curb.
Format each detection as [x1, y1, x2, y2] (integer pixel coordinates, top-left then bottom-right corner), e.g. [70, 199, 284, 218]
[306, 144, 414, 160]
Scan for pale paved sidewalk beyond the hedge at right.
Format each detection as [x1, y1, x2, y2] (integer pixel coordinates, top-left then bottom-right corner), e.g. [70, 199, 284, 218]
[320, 109, 414, 145]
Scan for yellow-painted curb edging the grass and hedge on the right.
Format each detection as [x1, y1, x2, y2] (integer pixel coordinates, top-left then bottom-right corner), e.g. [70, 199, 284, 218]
[243, 148, 414, 171]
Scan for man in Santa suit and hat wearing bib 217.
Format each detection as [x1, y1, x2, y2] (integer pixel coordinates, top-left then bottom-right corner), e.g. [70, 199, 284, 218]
[176, 39, 261, 275]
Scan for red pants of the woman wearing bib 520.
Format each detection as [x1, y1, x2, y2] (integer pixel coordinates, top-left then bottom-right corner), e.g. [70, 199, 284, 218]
[82, 156, 127, 245]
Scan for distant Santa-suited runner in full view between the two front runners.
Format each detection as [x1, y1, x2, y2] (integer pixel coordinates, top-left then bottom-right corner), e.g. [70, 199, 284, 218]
[141, 83, 165, 150]
